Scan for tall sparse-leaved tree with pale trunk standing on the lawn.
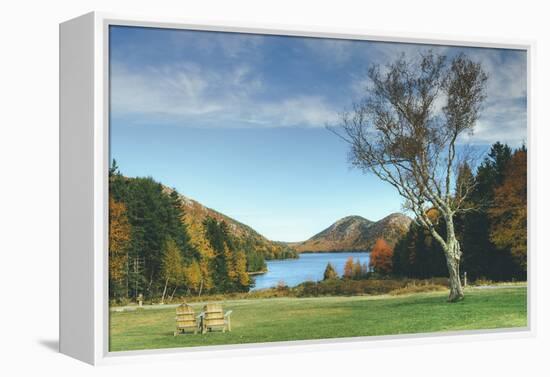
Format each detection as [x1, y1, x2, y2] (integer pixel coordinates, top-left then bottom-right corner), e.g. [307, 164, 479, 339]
[330, 51, 487, 301]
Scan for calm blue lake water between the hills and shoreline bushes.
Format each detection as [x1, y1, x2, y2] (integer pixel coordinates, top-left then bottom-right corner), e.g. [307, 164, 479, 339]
[253, 252, 370, 290]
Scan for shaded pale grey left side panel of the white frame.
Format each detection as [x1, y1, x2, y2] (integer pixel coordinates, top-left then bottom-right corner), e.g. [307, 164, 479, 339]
[59, 14, 97, 363]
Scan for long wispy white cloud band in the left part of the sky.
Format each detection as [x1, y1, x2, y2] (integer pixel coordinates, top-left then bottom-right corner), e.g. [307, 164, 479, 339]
[111, 60, 337, 127]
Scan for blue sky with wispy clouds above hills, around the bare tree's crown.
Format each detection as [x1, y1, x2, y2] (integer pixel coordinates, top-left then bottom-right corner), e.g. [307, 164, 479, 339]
[110, 27, 527, 241]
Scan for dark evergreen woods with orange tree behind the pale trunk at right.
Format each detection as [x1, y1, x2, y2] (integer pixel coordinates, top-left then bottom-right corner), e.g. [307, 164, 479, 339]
[392, 143, 527, 281]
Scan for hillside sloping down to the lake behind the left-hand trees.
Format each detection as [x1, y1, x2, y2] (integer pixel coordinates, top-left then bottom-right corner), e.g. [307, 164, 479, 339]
[164, 187, 297, 259]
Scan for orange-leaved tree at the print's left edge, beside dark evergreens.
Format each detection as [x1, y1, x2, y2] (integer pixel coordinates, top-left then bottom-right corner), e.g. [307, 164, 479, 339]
[109, 198, 131, 296]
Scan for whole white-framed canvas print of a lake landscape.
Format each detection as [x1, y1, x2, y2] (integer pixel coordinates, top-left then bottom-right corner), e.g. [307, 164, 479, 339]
[60, 13, 532, 363]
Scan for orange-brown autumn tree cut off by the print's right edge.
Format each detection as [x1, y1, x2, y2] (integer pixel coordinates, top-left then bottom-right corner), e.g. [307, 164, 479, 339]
[489, 148, 527, 273]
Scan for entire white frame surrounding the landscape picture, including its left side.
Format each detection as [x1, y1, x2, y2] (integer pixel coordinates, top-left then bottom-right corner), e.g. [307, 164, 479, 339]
[60, 12, 536, 364]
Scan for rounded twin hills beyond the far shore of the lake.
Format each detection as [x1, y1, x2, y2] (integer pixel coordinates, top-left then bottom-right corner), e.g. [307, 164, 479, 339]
[288, 213, 412, 253]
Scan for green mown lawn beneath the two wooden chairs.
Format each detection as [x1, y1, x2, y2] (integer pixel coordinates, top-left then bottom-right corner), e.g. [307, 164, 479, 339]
[110, 287, 527, 351]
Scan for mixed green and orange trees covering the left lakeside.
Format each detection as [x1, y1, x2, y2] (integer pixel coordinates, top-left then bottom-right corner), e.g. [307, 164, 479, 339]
[109, 161, 274, 301]
